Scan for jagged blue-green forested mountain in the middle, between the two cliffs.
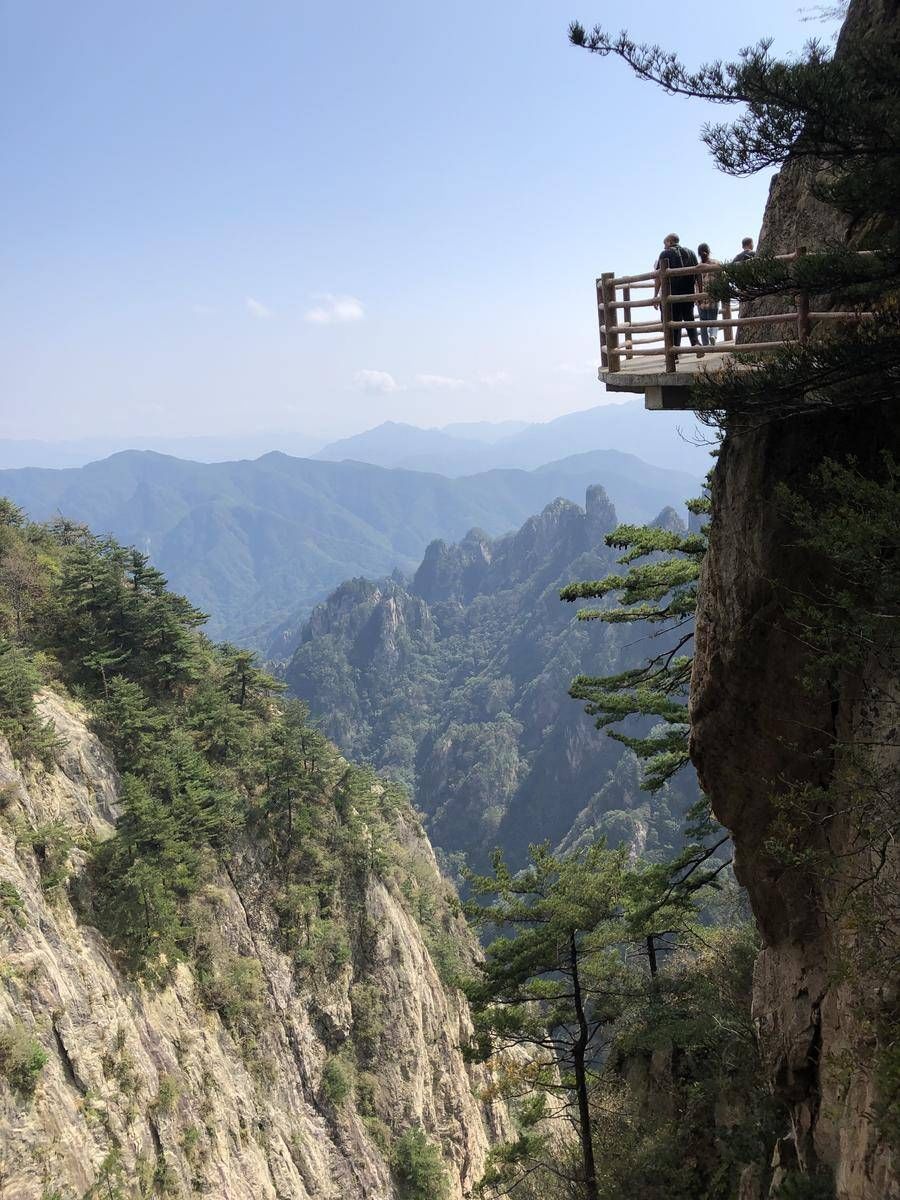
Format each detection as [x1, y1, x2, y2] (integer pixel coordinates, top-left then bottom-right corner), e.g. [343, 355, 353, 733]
[287, 487, 696, 863]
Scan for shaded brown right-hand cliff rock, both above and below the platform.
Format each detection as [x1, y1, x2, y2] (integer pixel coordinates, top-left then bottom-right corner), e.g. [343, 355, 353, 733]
[691, 0, 900, 1200]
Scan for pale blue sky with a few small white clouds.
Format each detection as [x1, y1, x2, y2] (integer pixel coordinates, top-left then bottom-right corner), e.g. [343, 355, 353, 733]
[0, 0, 844, 438]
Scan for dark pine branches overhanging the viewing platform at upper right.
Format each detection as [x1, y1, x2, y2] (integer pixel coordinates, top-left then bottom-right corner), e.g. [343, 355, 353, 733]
[569, 15, 900, 428]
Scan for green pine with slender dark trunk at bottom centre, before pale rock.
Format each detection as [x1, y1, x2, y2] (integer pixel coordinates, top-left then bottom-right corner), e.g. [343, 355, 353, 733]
[466, 842, 694, 1200]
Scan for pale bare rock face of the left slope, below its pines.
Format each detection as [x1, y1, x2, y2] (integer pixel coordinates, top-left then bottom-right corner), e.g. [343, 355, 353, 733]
[0, 691, 508, 1200]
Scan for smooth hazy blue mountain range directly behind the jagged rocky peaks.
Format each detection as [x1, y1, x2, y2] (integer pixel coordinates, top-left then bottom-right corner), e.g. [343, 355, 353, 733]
[0, 450, 698, 646]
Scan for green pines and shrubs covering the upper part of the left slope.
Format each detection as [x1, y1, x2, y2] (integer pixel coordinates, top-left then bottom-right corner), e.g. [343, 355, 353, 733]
[0, 504, 465, 1041]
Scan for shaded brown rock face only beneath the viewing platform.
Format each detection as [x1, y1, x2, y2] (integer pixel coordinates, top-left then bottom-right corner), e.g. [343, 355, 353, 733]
[692, 398, 900, 1200]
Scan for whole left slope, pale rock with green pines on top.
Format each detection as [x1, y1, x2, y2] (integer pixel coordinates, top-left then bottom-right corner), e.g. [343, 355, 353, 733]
[0, 502, 505, 1200]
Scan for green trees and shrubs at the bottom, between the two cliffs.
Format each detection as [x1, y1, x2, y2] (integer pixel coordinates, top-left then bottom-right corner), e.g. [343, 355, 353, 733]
[467, 844, 772, 1200]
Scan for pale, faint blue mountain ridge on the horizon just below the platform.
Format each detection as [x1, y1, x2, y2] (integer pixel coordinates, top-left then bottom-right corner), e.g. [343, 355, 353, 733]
[316, 400, 712, 478]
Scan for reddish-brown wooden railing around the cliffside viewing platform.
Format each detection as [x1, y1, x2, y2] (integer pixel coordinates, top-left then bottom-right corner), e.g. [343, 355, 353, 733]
[596, 247, 871, 372]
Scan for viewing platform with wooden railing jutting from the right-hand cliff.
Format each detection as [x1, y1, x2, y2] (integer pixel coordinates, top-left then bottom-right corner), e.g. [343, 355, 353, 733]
[596, 247, 871, 409]
